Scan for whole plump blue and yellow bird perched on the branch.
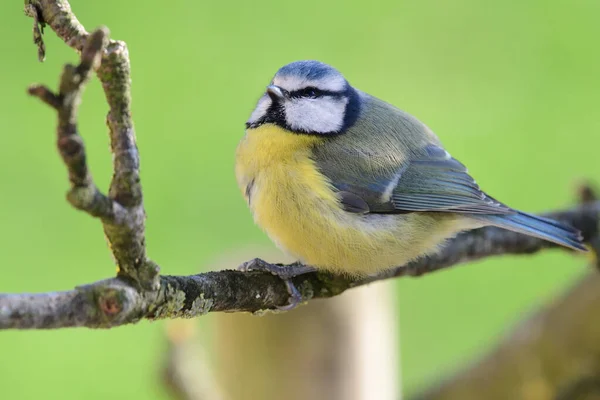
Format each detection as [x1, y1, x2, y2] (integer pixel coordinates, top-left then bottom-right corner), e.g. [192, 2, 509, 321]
[235, 61, 585, 288]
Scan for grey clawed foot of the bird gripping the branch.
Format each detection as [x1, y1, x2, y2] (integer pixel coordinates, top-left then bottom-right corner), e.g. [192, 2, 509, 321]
[238, 258, 316, 311]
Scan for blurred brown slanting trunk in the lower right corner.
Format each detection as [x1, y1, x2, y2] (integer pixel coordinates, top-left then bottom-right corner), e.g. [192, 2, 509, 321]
[418, 273, 600, 400]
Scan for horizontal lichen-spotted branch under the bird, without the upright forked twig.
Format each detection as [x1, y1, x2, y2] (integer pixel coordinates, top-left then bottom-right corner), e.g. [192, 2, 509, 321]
[0, 202, 600, 329]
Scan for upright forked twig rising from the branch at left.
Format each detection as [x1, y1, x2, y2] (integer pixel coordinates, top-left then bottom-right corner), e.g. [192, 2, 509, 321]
[26, 0, 159, 290]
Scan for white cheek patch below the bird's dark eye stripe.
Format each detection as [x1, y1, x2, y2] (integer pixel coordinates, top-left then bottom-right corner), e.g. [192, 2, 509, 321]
[285, 96, 348, 133]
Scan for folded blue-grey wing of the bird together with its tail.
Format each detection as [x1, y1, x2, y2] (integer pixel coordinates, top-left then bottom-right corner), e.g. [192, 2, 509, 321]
[334, 145, 586, 251]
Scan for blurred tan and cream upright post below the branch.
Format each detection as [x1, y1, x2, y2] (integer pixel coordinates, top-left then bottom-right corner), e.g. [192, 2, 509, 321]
[213, 248, 400, 400]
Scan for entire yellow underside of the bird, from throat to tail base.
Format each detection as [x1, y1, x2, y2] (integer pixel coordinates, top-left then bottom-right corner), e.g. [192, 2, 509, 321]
[236, 124, 461, 276]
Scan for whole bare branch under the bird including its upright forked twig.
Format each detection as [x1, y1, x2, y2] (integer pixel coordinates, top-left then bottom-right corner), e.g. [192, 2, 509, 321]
[0, 0, 600, 329]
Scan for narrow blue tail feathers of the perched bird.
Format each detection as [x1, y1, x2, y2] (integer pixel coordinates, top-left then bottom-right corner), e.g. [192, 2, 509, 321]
[482, 211, 587, 251]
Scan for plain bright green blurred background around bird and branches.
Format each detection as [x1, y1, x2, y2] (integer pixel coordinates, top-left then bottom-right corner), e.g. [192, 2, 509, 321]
[0, 0, 600, 400]
